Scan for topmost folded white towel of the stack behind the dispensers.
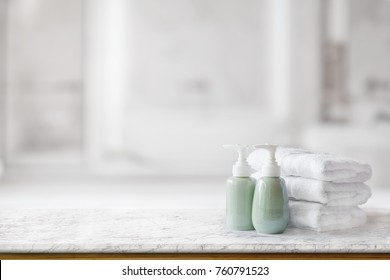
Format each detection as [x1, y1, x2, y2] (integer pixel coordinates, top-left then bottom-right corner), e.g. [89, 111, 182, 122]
[248, 147, 372, 183]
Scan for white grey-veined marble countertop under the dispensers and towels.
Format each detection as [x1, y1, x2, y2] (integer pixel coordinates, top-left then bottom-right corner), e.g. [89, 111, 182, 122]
[0, 209, 390, 253]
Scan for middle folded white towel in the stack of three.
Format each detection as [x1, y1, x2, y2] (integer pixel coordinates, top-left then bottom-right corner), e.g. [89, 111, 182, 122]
[252, 172, 371, 206]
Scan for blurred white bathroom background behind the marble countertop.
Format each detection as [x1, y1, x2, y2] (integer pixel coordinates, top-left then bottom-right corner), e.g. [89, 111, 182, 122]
[0, 0, 390, 207]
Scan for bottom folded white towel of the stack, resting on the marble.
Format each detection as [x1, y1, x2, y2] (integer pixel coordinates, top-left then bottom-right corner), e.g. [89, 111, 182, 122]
[289, 201, 367, 231]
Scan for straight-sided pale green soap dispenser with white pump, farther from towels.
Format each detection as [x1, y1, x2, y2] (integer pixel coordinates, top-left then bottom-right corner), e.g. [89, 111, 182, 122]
[224, 145, 256, 230]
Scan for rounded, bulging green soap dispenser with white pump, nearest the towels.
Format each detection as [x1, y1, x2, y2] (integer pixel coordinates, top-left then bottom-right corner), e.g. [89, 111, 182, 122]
[252, 145, 290, 233]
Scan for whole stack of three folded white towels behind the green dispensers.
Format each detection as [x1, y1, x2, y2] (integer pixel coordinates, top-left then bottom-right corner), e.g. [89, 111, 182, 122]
[248, 147, 372, 231]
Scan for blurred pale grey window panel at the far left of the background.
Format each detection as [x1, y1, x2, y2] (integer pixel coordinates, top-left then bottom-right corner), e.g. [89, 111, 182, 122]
[3, 0, 83, 168]
